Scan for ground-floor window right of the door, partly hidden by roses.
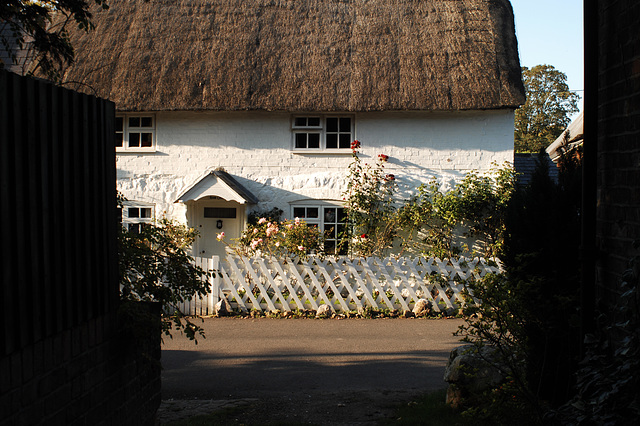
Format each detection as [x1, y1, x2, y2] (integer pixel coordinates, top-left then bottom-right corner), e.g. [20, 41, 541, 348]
[292, 205, 347, 254]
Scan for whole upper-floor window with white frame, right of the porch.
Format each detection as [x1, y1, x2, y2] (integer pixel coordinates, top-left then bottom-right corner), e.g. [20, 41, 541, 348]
[291, 115, 354, 152]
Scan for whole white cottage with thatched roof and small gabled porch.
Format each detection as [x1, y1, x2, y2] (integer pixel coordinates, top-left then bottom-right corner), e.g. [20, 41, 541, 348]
[63, 0, 524, 256]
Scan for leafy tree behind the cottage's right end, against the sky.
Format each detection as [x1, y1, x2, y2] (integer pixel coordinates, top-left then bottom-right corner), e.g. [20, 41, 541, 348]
[514, 65, 580, 152]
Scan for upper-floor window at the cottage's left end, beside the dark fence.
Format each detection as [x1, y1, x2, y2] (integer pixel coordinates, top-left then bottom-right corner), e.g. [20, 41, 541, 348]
[116, 114, 156, 152]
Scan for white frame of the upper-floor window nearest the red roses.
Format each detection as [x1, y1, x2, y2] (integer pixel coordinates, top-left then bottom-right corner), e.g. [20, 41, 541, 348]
[291, 114, 355, 154]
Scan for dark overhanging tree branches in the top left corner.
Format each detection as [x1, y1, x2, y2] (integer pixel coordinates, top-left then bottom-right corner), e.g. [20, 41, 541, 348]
[0, 0, 108, 80]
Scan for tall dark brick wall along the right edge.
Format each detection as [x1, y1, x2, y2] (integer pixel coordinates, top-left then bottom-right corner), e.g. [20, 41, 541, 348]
[587, 0, 640, 294]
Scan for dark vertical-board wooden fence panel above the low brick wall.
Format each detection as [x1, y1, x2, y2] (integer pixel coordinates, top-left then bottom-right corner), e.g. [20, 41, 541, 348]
[0, 71, 118, 355]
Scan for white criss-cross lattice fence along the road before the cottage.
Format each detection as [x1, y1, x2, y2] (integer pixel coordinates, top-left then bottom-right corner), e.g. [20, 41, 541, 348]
[175, 255, 501, 315]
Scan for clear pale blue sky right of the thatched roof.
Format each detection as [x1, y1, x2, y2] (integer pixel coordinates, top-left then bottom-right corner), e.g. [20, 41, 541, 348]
[511, 0, 584, 112]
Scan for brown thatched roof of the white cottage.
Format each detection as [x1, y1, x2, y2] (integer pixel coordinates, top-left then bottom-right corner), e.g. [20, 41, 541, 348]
[64, 0, 524, 111]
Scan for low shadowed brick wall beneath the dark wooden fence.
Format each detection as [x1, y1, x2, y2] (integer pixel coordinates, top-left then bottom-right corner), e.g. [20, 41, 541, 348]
[0, 315, 160, 426]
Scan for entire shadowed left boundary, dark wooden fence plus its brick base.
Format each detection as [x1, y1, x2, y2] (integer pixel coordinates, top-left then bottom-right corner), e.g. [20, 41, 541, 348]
[0, 70, 160, 426]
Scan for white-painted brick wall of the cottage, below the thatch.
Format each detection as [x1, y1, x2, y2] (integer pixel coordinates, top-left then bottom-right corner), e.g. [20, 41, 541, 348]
[117, 110, 514, 222]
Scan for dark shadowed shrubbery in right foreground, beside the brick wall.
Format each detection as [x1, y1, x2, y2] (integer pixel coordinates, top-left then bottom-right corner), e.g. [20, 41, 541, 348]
[458, 154, 580, 424]
